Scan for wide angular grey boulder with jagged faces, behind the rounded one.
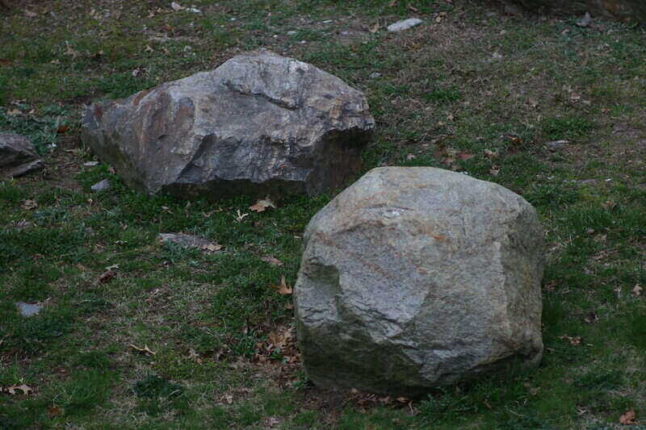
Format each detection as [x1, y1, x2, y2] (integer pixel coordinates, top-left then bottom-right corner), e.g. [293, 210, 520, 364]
[83, 51, 374, 198]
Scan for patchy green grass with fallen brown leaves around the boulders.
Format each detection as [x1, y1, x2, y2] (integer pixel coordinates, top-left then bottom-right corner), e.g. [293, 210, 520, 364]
[0, 0, 646, 429]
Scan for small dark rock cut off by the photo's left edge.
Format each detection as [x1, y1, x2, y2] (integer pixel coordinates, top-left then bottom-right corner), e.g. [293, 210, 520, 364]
[0, 133, 45, 178]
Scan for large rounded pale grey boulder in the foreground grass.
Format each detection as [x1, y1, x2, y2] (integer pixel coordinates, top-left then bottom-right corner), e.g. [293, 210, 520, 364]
[294, 167, 544, 396]
